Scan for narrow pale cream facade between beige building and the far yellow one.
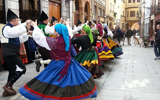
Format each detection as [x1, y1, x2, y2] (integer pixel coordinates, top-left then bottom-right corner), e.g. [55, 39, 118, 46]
[106, 0, 116, 28]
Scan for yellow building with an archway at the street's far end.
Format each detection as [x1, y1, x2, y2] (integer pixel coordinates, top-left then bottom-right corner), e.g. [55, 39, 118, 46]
[125, 0, 141, 29]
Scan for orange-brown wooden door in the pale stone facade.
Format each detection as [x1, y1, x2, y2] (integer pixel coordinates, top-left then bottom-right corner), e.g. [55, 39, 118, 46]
[49, 2, 61, 21]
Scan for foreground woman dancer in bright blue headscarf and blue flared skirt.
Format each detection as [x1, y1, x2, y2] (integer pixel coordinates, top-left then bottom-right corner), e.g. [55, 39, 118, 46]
[19, 22, 97, 100]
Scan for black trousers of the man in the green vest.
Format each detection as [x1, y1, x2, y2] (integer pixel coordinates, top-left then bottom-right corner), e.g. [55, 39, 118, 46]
[38, 47, 51, 67]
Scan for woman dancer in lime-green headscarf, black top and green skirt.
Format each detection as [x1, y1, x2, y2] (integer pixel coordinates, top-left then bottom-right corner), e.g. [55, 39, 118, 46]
[72, 25, 104, 78]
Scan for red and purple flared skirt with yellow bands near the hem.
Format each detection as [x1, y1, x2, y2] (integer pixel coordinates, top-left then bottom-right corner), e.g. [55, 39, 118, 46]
[97, 42, 114, 61]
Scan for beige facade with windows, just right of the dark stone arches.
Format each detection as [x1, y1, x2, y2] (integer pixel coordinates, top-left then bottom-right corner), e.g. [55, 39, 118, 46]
[92, 0, 106, 23]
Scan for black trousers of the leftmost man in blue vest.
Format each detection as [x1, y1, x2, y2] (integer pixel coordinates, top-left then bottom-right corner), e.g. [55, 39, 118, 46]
[3, 55, 26, 85]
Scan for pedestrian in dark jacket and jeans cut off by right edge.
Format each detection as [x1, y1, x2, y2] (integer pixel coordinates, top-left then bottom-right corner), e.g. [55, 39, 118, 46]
[154, 24, 160, 60]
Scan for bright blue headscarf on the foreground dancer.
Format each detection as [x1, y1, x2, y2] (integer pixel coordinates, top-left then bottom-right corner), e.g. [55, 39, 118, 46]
[55, 24, 70, 51]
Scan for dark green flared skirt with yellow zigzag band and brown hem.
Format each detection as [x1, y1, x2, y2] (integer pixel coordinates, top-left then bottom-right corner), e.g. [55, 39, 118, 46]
[74, 49, 104, 78]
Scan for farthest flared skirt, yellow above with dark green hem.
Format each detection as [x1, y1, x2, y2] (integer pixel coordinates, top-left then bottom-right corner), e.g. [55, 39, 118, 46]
[103, 38, 123, 57]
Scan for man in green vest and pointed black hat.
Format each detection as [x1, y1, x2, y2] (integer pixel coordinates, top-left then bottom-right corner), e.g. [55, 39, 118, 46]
[35, 11, 54, 69]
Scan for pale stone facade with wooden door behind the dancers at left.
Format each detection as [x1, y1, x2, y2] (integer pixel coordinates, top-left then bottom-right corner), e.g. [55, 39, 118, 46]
[0, 0, 73, 23]
